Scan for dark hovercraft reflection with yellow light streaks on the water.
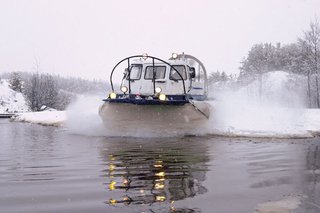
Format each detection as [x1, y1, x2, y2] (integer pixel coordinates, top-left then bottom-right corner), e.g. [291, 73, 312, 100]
[101, 138, 209, 212]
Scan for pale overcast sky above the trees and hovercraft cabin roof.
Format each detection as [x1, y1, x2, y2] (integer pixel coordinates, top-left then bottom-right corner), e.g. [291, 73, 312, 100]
[0, 0, 320, 79]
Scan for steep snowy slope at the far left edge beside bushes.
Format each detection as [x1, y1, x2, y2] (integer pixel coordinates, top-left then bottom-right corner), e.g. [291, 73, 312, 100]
[0, 79, 30, 114]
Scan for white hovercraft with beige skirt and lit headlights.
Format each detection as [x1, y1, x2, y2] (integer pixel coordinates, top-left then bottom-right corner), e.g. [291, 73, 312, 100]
[99, 53, 210, 131]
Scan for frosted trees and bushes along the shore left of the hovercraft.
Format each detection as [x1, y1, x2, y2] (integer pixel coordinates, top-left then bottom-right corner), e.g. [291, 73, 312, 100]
[2, 72, 109, 111]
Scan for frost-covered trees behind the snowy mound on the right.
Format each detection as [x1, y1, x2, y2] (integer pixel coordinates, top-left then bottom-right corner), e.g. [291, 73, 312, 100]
[238, 18, 320, 108]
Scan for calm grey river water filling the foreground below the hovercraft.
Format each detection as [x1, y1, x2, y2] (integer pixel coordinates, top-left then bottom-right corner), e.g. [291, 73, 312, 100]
[0, 119, 320, 213]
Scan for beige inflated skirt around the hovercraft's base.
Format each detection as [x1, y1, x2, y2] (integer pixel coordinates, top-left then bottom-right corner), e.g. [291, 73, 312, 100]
[99, 101, 210, 136]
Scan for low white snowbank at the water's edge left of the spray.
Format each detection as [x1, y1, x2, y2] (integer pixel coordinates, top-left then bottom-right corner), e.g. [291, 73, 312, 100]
[12, 111, 67, 126]
